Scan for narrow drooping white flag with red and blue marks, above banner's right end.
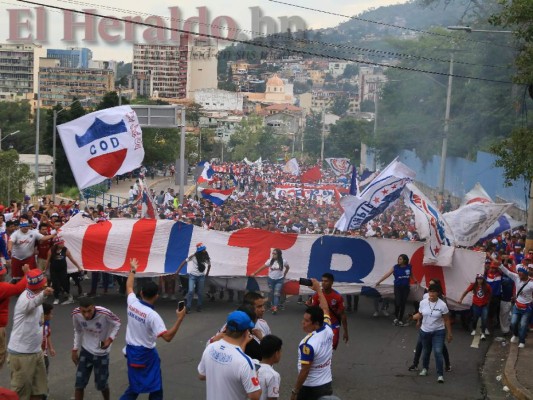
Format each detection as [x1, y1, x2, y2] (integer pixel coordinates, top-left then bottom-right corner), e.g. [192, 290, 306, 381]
[404, 183, 453, 266]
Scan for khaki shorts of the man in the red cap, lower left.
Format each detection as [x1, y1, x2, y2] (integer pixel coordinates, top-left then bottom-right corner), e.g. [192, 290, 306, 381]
[7, 352, 48, 399]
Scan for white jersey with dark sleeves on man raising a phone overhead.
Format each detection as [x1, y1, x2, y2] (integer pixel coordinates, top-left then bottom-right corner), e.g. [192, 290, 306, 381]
[298, 315, 333, 387]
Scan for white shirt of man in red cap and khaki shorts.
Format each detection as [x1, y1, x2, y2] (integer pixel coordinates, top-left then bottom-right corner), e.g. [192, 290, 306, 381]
[7, 289, 44, 354]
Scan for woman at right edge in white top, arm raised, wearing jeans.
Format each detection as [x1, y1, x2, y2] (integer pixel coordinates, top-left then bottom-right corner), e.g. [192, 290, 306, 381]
[500, 264, 533, 348]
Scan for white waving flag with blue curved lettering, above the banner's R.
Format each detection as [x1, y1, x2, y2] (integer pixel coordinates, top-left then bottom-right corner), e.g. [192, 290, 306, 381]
[335, 159, 416, 230]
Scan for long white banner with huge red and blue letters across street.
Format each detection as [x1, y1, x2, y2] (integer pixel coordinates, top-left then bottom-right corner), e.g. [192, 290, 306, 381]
[61, 214, 485, 300]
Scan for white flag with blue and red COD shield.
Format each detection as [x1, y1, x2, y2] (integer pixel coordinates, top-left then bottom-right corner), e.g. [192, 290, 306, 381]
[57, 106, 144, 189]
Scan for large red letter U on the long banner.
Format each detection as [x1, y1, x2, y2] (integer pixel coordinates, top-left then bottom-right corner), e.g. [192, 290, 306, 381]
[81, 219, 157, 272]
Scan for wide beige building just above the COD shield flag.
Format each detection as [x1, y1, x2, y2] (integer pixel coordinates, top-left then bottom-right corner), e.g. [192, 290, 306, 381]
[39, 67, 115, 108]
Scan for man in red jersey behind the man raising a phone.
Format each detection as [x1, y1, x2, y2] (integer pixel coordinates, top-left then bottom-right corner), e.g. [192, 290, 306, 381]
[310, 272, 349, 350]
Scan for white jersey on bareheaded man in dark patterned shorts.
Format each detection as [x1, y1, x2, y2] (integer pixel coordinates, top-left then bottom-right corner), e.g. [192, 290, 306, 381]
[72, 306, 120, 356]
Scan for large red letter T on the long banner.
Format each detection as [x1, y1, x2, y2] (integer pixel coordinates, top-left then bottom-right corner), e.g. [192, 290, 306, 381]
[228, 228, 298, 275]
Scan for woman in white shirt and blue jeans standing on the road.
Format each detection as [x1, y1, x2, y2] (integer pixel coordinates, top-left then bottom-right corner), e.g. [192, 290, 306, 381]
[413, 285, 452, 383]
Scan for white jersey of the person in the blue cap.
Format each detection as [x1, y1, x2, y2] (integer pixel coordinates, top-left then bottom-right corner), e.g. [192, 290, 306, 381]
[198, 339, 261, 400]
